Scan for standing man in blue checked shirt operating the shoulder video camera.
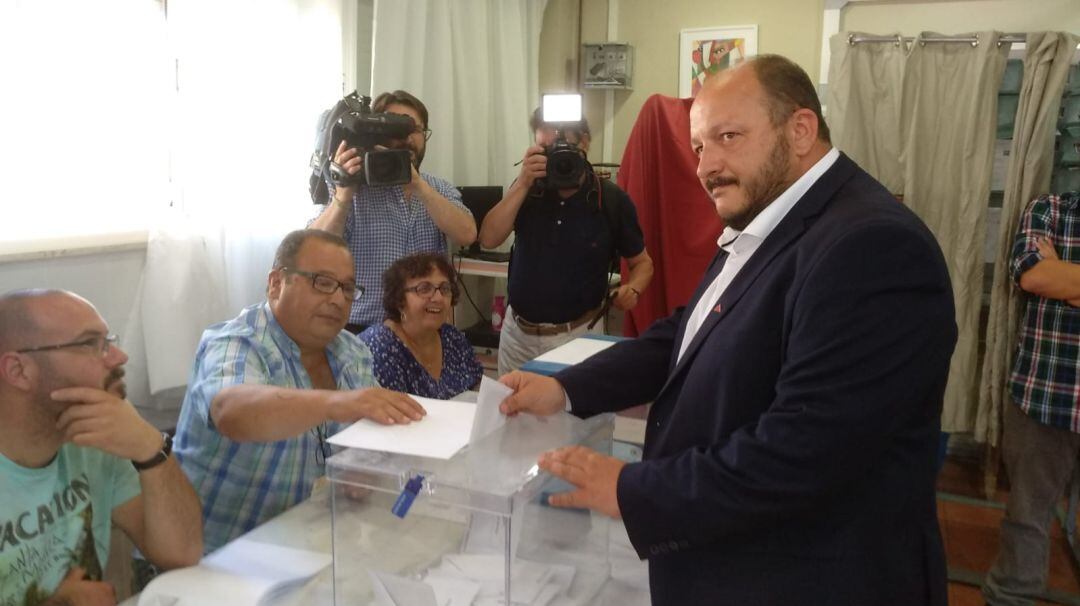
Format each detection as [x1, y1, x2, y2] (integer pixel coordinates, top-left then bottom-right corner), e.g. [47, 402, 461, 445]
[309, 91, 476, 334]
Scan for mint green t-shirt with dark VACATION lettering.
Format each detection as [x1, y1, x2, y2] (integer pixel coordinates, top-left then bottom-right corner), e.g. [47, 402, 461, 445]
[0, 444, 139, 606]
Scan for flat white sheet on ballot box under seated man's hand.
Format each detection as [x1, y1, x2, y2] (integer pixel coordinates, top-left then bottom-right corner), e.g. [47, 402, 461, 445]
[327, 395, 476, 459]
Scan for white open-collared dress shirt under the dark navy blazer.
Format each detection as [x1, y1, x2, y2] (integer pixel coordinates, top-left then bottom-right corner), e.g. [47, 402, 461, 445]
[675, 148, 840, 364]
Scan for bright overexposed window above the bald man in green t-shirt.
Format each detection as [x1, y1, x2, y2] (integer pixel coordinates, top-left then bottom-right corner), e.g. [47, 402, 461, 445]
[0, 0, 172, 241]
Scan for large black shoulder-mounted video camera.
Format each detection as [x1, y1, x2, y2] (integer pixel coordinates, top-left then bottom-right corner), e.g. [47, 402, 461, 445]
[309, 92, 416, 204]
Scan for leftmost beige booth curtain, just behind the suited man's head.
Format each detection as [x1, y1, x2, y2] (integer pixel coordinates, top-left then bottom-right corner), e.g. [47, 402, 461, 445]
[825, 31, 907, 196]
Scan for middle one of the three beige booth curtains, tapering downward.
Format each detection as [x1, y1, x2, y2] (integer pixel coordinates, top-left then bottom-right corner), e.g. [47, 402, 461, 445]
[901, 31, 1010, 432]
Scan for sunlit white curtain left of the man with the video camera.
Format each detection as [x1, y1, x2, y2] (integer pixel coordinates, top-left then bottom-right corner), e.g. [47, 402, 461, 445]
[137, 0, 343, 401]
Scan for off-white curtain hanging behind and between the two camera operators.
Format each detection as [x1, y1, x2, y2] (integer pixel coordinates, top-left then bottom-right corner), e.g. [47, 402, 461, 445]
[372, 0, 546, 186]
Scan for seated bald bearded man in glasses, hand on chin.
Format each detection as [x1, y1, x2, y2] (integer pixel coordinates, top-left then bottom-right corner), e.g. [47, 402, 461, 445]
[0, 289, 202, 606]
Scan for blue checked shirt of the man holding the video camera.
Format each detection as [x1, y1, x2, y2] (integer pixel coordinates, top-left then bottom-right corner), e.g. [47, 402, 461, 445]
[332, 173, 472, 325]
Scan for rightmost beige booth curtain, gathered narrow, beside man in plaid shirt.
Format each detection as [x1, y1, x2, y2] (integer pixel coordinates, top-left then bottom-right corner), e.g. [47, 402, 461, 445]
[975, 31, 1080, 446]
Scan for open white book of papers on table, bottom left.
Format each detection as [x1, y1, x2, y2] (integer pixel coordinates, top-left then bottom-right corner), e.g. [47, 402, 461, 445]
[138, 538, 332, 606]
